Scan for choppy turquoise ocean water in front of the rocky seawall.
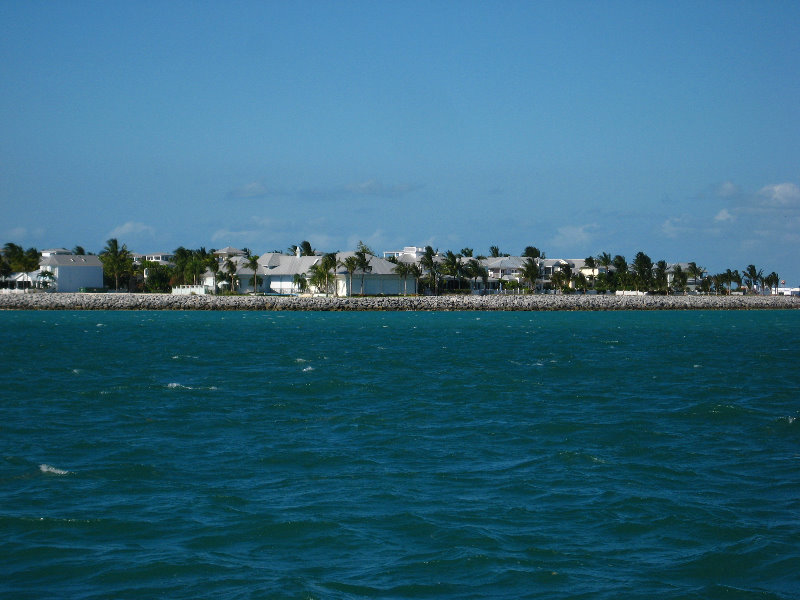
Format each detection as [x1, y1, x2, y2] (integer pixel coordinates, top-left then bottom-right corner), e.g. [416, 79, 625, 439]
[0, 311, 800, 599]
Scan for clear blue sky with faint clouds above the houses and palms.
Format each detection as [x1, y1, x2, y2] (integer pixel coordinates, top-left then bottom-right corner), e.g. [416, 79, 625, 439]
[0, 1, 800, 285]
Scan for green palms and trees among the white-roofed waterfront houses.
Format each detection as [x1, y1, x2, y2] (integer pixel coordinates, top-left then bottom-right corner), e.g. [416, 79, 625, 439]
[0, 238, 780, 295]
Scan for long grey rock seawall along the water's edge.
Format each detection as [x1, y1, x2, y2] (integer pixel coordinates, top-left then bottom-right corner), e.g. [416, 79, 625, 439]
[0, 293, 800, 311]
